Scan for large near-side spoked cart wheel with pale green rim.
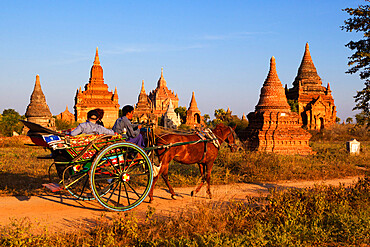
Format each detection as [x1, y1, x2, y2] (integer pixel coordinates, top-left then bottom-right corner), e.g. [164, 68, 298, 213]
[90, 142, 153, 211]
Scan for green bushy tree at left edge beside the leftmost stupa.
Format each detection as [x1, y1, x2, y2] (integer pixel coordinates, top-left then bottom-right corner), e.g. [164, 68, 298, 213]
[0, 109, 25, 136]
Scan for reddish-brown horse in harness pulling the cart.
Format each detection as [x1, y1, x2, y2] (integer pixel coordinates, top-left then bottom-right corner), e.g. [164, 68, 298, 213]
[149, 123, 236, 202]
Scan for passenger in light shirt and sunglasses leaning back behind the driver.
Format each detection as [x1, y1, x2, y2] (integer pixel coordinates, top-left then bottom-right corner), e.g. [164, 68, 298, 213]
[70, 110, 115, 136]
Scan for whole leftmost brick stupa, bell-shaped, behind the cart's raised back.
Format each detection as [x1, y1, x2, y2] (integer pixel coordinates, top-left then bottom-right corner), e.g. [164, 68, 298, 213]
[25, 75, 56, 130]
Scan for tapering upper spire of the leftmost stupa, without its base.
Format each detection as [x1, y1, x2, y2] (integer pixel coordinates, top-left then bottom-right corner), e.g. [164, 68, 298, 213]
[25, 75, 52, 118]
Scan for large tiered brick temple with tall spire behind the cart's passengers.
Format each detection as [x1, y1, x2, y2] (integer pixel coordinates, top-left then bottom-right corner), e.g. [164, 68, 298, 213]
[74, 48, 119, 127]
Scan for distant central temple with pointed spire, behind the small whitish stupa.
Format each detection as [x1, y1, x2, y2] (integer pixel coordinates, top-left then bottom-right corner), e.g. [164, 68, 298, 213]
[149, 68, 179, 117]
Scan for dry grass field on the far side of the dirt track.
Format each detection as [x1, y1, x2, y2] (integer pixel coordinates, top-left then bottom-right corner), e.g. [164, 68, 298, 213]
[0, 129, 370, 196]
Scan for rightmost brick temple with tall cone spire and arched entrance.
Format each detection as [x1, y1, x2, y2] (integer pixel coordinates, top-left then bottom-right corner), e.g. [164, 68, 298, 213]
[286, 43, 337, 130]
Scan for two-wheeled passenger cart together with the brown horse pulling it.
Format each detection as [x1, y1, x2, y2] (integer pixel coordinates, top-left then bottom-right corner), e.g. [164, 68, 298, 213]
[21, 120, 235, 211]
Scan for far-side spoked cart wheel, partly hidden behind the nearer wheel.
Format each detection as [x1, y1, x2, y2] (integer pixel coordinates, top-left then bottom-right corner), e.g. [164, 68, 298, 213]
[63, 161, 95, 201]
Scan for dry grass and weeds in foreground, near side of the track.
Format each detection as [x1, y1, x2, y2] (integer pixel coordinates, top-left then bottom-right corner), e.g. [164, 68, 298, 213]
[0, 179, 370, 247]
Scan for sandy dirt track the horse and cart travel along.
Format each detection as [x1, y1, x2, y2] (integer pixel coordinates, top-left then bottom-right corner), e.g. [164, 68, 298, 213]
[0, 177, 358, 231]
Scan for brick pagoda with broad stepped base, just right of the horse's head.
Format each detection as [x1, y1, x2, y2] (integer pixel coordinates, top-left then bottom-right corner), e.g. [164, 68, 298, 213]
[246, 57, 312, 155]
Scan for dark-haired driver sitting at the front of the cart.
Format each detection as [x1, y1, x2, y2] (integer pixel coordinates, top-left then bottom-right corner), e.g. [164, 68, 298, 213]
[112, 105, 145, 148]
